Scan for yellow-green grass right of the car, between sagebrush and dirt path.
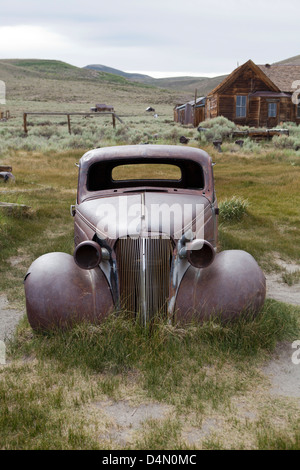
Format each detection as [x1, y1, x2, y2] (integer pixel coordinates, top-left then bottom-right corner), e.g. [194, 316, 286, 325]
[214, 151, 300, 268]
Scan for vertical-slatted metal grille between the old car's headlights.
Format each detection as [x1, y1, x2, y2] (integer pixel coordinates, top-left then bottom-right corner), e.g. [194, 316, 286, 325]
[116, 237, 173, 325]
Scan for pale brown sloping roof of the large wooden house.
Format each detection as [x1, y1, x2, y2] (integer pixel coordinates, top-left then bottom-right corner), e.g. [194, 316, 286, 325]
[258, 64, 300, 93]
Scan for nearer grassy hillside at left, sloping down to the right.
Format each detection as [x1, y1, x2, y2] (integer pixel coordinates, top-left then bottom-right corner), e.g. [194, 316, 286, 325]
[0, 59, 185, 114]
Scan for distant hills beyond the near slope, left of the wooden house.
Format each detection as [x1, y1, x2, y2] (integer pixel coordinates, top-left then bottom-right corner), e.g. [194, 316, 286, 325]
[84, 64, 226, 96]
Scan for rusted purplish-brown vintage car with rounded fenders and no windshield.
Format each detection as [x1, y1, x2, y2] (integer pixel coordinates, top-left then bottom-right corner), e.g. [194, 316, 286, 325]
[24, 145, 266, 329]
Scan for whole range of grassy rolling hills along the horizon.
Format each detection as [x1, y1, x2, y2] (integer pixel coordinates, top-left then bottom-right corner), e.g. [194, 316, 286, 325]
[0, 55, 300, 115]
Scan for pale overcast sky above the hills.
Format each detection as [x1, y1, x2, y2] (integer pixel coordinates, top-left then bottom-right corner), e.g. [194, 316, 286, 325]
[0, 0, 300, 76]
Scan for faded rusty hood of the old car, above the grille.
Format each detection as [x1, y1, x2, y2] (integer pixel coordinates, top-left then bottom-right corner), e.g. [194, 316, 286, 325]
[76, 192, 212, 240]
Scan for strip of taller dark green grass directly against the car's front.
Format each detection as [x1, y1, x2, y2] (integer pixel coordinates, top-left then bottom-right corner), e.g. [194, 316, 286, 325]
[11, 301, 297, 378]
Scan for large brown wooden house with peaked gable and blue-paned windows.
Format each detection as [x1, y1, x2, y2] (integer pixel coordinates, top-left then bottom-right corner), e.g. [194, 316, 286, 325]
[205, 60, 300, 128]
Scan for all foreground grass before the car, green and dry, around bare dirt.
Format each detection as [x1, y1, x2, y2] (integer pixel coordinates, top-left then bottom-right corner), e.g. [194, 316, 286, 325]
[0, 301, 299, 449]
